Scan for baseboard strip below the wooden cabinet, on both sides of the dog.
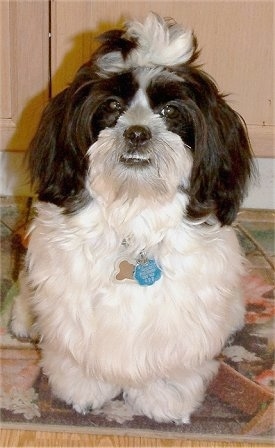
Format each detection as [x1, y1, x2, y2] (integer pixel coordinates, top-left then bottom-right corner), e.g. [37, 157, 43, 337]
[0, 151, 275, 210]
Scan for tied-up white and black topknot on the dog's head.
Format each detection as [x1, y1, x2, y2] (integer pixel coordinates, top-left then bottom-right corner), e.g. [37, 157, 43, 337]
[97, 12, 198, 72]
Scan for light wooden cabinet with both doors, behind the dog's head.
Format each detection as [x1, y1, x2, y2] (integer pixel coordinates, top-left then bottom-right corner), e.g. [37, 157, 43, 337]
[0, 0, 275, 156]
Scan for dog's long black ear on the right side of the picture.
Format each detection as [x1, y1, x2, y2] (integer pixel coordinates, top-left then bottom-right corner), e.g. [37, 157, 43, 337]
[188, 74, 253, 225]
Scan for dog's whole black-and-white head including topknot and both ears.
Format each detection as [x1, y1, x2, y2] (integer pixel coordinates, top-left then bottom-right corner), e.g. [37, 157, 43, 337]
[29, 14, 252, 225]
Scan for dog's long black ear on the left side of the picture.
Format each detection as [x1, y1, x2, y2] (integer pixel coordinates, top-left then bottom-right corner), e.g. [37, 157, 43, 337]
[28, 72, 92, 206]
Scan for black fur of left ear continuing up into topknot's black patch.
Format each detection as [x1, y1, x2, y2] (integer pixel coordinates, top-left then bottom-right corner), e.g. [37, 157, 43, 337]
[28, 30, 136, 212]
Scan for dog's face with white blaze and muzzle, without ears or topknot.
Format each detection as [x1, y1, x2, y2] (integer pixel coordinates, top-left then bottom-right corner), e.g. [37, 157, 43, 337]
[88, 68, 194, 202]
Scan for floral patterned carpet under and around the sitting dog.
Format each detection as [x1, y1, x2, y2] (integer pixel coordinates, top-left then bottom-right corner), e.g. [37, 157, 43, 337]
[0, 197, 275, 444]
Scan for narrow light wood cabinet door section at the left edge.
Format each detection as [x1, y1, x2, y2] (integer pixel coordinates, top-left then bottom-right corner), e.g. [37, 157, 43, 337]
[0, 0, 49, 151]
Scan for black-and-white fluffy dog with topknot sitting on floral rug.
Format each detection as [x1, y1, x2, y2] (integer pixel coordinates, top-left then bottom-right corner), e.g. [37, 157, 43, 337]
[11, 13, 253, 424]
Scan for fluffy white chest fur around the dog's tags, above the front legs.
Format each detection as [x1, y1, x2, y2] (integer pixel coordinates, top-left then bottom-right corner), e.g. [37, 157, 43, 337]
[28, 195, 244, 383]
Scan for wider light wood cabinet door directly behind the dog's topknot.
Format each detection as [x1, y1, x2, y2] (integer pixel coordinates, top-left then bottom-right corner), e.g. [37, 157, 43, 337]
[51, 0, 275, 156]
